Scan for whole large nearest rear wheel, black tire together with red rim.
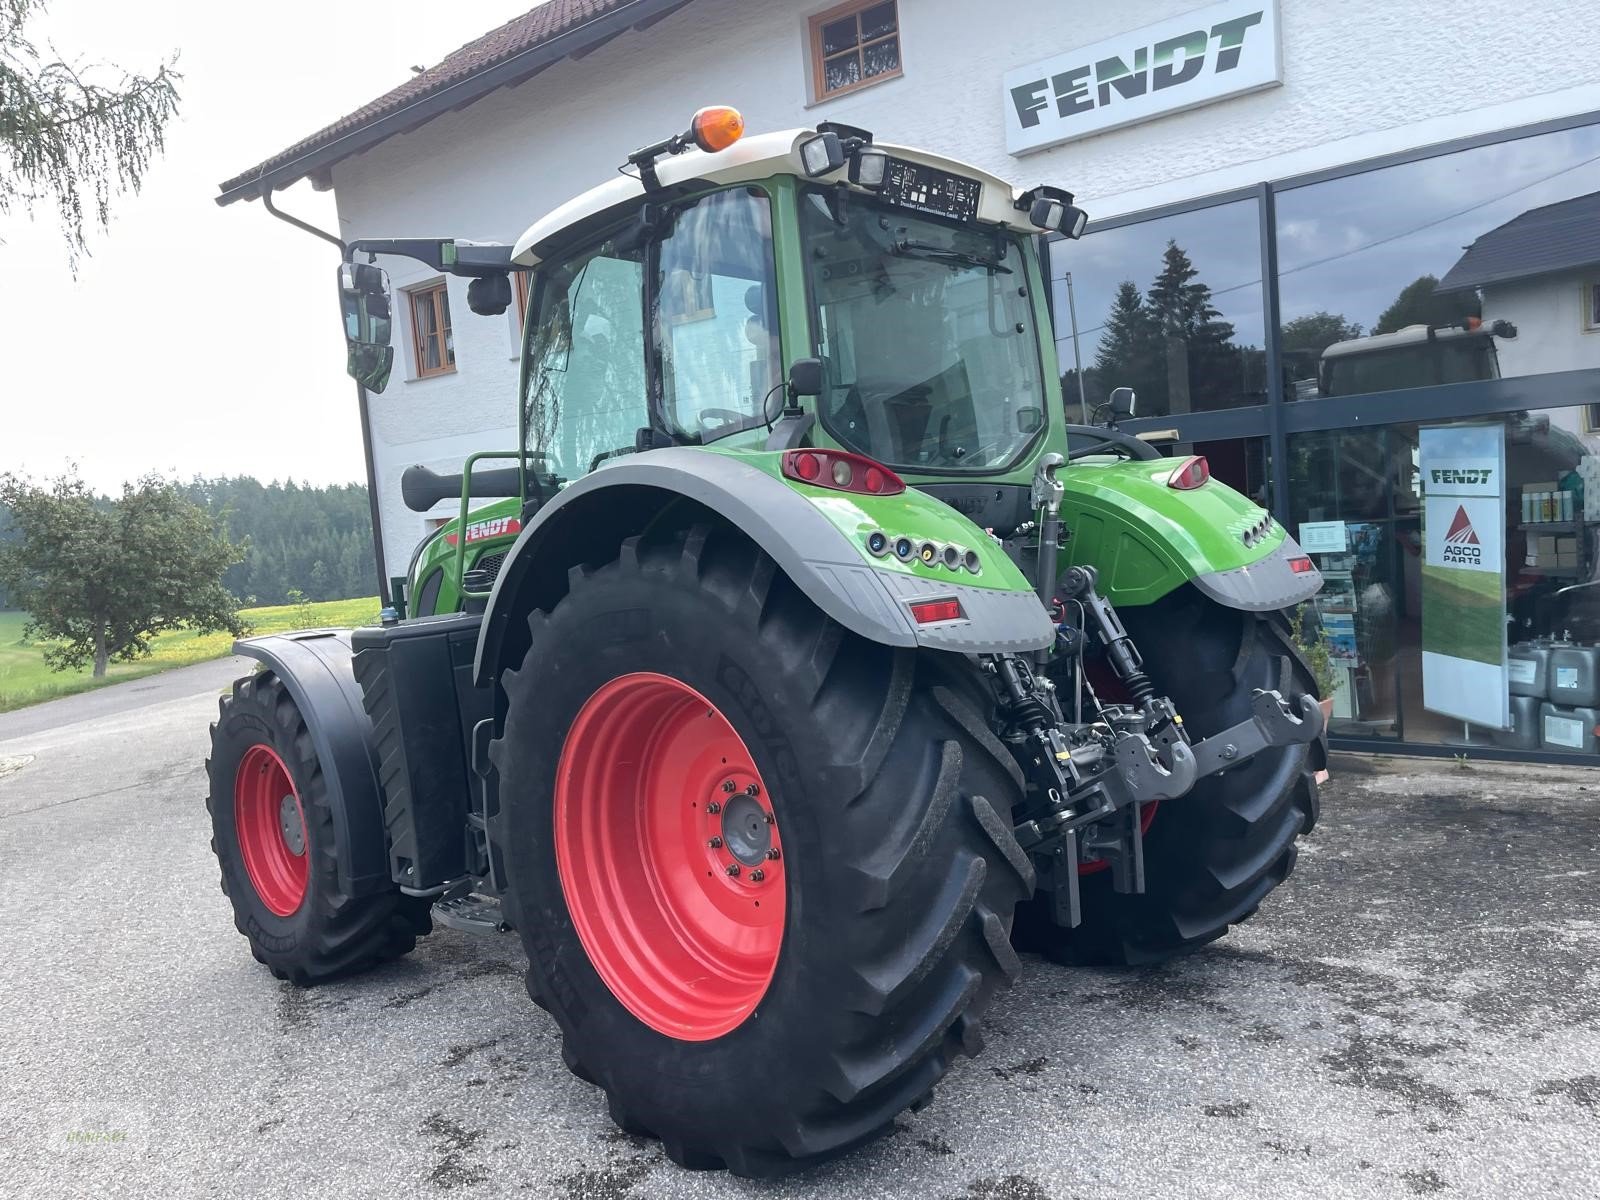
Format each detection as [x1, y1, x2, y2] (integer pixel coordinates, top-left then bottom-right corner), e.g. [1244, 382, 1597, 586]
[491, 526, 1032, 1176]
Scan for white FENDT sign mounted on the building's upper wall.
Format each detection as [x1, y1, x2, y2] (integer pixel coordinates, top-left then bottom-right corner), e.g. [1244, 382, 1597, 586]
[1005, 0, 1283, 154]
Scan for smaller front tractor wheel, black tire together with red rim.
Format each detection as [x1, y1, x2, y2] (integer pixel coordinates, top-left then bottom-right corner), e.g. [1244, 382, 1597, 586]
[206, 672, 432, 986]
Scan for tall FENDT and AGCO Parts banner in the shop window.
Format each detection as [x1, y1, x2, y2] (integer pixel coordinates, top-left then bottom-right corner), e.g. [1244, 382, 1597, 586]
[1418, 424, 1510, 730]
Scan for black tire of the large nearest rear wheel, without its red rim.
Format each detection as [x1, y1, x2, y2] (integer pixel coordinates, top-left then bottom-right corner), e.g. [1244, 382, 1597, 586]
[490, 525, 1034, 1176]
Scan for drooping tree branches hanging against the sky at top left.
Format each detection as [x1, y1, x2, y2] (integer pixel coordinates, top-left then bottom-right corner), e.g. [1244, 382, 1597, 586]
[0, 0, 182, 262]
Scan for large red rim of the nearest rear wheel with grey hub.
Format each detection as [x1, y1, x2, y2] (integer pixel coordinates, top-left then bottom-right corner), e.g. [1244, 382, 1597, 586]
[555, 672, 786, 1042]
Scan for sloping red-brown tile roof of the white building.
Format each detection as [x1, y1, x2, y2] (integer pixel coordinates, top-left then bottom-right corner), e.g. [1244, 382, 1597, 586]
[219, 0, 688, 203]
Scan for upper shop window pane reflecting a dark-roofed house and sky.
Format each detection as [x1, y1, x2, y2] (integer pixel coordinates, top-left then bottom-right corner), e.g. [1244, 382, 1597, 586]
[1277, 125, 1600, 400]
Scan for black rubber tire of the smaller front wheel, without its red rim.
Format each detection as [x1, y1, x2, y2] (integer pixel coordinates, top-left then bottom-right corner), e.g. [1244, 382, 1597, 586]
[206, 670, 432, 987]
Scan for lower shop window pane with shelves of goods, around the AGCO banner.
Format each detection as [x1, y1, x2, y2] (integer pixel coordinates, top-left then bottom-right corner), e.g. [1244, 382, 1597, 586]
[1288, 406, 1600, 765]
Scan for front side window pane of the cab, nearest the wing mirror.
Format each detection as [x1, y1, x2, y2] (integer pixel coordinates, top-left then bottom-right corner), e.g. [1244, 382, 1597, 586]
[522, 242, 650, 480]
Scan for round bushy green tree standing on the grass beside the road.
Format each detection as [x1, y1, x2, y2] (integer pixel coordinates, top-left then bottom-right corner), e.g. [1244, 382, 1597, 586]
[0, 474, 246, 678]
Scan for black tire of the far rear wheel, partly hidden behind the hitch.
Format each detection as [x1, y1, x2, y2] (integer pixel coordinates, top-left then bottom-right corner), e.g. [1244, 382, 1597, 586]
[1016, 586, 1325, 966]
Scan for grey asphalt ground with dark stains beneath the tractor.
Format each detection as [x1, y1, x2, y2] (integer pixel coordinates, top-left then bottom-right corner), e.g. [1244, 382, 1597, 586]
[0, 662, 1600, 1200]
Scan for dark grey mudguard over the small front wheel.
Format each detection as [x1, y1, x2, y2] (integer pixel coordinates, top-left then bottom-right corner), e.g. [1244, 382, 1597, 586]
[234, 629, 394, 896]
